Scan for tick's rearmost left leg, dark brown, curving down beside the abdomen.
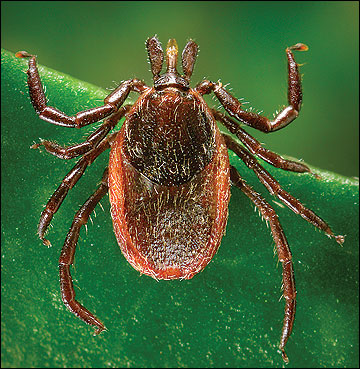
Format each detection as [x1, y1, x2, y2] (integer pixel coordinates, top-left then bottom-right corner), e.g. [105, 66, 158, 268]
[59, 168, 108, 334]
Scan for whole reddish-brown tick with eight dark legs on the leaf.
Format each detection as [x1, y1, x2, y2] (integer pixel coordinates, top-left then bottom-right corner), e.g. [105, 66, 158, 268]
[16, 37, 344, 362]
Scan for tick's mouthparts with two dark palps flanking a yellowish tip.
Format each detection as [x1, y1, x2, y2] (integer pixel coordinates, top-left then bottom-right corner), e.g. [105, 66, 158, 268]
[146, 36, 198, 90]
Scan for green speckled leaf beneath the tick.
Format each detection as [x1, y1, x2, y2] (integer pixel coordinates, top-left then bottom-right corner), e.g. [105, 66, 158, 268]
[1, 51, 359, 367]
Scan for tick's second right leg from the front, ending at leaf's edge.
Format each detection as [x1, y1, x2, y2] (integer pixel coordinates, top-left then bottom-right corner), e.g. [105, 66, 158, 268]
[211, 109, 310, 173]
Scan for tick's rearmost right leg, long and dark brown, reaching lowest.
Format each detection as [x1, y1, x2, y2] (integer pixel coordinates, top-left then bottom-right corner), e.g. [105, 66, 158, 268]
[230, 166, 296, 363]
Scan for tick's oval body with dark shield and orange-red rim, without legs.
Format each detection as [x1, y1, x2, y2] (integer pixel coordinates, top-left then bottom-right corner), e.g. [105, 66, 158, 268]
[109, 90, 229, 279]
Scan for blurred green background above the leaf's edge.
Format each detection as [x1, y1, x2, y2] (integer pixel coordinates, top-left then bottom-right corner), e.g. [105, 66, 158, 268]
[1, 1, 359, 176]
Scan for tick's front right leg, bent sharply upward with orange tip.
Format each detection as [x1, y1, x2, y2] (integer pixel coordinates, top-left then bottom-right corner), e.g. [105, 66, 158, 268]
[195, 44, 308, 132]
